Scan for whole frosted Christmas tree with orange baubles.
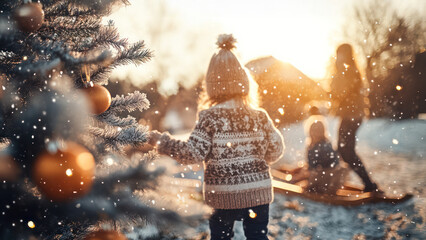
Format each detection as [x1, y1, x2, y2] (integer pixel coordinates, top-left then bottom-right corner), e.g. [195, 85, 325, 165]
[0, 0, 190, 239]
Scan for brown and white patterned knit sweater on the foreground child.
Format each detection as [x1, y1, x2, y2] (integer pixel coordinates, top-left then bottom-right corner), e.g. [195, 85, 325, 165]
[158, 100, 284, 209]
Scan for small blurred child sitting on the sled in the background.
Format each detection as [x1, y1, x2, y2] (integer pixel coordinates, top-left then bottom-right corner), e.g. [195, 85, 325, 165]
[305, 107, 347, 194]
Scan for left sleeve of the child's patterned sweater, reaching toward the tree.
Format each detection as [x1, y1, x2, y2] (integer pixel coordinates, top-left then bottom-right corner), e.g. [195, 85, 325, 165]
[158, 111, 212, 164]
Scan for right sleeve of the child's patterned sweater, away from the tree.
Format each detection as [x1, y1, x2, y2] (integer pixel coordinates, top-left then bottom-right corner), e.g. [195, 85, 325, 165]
[265, 113, 285, 164]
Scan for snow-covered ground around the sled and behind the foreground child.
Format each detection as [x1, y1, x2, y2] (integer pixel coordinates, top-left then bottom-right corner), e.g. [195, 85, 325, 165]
[128, 118, 426, 240]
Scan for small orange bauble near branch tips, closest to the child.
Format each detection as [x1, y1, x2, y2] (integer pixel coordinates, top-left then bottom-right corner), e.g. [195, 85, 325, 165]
[83, 85, 111, 114]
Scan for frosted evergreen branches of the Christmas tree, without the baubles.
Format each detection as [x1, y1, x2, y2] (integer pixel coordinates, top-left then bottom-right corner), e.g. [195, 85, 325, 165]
[0, 0, 195, 236]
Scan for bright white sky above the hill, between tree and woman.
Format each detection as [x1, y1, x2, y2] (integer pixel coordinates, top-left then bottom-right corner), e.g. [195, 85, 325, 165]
[168, 0, 348, 78]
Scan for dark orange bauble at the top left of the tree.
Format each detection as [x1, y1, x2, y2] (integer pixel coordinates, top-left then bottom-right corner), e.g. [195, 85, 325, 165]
[13, 3, 44, 32]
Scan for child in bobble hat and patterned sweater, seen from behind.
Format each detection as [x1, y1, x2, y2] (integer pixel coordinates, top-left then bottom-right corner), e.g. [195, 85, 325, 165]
[149, 34, 284, 240]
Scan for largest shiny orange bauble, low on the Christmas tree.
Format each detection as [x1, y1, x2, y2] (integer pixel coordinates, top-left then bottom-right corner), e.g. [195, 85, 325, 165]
[33, 141, 95, 201]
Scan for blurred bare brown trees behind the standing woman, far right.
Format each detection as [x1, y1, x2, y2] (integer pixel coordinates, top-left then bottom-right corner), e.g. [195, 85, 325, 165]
[343, 0, 426, 120]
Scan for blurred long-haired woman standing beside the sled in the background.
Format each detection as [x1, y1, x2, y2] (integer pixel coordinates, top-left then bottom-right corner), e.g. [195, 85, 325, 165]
[331, 44, 379, 192]
